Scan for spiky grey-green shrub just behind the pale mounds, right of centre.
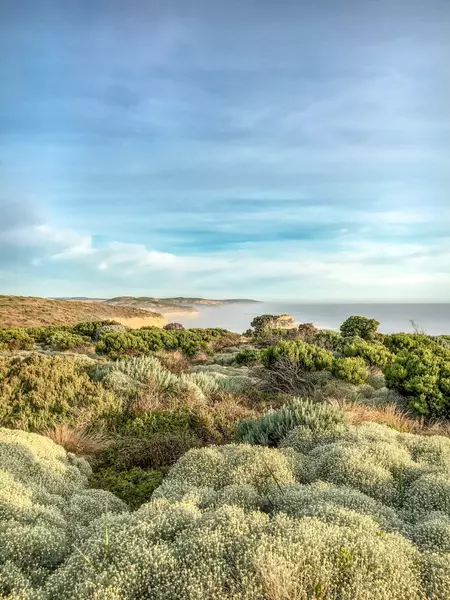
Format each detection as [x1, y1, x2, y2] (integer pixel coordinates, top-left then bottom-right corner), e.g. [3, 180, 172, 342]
[236, 399, 345, 446]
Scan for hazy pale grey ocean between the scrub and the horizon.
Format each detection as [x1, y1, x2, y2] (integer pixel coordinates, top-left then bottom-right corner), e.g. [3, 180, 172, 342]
[173, 303, 450, 335]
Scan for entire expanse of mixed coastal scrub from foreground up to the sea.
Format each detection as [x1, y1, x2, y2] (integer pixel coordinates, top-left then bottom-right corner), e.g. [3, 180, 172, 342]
[0, 315, 450, 600]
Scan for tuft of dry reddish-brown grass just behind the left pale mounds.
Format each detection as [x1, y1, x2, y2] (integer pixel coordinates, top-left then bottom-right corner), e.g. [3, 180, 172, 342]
[41, 425, 110, 458]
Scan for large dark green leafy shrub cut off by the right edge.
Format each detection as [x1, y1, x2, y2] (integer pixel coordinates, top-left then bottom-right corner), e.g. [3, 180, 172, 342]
[384, 345, 450, 418]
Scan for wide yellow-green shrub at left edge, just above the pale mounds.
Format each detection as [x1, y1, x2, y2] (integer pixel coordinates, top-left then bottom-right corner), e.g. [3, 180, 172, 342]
[0, 354, 123, 431]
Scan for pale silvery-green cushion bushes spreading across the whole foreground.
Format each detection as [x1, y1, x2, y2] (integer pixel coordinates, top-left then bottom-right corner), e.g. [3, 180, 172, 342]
[4, 423, 450, 600]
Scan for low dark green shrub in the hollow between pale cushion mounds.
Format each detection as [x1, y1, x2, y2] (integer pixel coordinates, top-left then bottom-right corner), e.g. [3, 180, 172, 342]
[91, 467, 163, 508]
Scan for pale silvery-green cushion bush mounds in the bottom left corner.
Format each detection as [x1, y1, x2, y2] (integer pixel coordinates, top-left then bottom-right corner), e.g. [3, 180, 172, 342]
[0, 428, 126, 598]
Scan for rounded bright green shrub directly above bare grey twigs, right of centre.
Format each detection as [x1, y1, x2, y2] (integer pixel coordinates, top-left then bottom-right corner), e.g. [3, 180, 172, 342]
[261, 340, 333, 371]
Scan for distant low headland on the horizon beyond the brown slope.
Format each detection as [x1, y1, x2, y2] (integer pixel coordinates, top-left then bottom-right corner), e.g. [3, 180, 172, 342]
[105, 296, 257, 314]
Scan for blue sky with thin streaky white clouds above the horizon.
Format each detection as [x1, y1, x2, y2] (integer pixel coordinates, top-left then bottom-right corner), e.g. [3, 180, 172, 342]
[0, 0, 450, 302]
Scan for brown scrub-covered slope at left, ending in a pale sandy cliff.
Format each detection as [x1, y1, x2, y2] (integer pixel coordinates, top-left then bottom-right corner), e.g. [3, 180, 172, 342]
[0, 296, 167, 328]
